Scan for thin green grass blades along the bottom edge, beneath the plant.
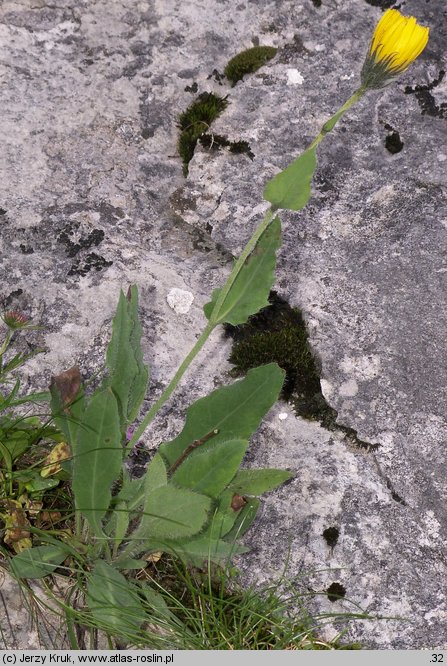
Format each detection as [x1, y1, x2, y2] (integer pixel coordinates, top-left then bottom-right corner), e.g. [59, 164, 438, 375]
[5, 556, 369, 650]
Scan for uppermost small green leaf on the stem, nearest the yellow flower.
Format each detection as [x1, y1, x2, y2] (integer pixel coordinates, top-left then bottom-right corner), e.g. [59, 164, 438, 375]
[264, 148, 317, 210]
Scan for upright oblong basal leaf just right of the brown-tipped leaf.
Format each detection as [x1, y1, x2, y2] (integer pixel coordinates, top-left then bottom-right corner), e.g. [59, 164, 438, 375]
[72, 388, 123, 536]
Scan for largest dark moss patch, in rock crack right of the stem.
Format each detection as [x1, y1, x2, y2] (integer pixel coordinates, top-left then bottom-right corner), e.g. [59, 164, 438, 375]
[225, 291, 377, 450]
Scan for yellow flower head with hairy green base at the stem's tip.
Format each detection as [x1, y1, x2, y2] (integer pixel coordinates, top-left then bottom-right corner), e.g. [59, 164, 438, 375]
[362, 9, 429, 88]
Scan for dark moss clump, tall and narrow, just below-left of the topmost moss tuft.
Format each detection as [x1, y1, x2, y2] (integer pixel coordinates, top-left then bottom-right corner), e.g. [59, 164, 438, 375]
[177, 92, 228, 176]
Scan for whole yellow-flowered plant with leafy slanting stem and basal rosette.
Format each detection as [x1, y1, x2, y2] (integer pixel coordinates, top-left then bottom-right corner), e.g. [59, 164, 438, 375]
[7, 10, 429, 642]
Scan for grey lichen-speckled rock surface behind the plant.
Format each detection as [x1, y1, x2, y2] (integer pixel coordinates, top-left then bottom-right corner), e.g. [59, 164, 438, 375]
[0, 0, 447, 649]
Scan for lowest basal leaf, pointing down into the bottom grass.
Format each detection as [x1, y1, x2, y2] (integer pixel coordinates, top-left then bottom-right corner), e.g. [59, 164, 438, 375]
[87, 560, 144, 633]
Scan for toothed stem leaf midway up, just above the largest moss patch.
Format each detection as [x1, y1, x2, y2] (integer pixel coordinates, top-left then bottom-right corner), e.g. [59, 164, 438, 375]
[204, 218, 281, 326]
